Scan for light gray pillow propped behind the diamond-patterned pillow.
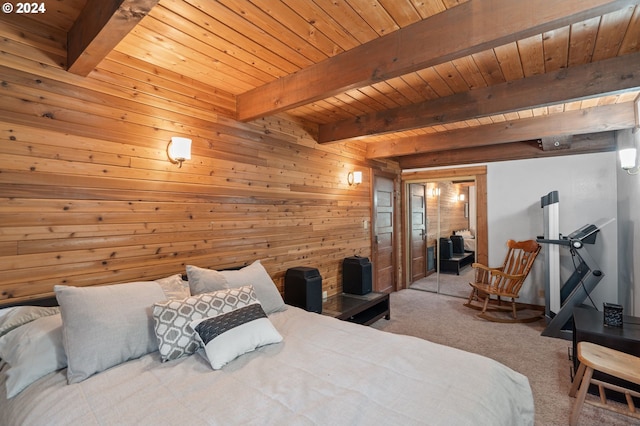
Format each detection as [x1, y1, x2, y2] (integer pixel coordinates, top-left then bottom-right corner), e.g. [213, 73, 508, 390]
[187, 260, 285, 315]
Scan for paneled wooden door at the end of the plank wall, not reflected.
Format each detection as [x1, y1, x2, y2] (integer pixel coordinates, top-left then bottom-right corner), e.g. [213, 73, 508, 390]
[372, 175, 396, 292]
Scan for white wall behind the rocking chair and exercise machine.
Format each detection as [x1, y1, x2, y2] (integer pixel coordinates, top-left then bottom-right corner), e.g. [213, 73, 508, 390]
[487, 152, 620, 313]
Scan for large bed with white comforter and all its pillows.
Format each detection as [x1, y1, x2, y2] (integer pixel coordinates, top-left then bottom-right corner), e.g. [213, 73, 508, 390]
[0, 262, 534, 426]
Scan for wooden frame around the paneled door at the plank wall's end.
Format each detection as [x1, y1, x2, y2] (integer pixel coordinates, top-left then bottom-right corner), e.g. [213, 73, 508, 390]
[369, 169, 402, 292]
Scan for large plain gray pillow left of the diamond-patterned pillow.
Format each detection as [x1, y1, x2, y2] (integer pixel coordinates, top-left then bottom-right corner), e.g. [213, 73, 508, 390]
[54, 282, 166, 384]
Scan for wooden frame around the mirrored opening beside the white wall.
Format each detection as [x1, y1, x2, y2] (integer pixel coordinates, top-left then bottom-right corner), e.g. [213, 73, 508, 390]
[399, 166, 489, 288]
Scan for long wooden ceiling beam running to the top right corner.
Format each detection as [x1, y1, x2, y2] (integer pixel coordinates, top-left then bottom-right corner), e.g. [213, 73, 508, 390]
[237, 0, 634, 121]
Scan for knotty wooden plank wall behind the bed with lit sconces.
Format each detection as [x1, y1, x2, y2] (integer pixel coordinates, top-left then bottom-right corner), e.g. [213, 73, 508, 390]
[0, 20, 399, 304]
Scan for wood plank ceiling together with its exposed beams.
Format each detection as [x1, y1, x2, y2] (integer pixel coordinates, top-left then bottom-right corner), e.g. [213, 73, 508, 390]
[5, 0, 640, 168]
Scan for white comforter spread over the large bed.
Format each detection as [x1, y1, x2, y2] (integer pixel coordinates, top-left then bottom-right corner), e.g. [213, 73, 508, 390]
[0, 307, 534, 426]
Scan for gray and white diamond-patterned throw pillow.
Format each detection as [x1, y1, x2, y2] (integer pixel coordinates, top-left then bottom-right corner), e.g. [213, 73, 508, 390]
[153, 286, 256, 362]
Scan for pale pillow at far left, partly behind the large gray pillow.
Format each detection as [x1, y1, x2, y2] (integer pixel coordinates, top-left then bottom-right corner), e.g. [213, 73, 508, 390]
[0, 314, 67, 398]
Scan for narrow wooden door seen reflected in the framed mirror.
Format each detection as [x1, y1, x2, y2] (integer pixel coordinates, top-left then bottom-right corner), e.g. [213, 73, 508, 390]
[409, 183, 427, 282]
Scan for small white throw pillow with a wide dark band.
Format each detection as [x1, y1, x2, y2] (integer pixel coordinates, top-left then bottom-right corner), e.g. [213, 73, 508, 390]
[190, 289, 282, 370]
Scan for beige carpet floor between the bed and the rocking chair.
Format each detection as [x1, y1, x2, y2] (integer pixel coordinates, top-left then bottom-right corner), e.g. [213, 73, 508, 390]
[372, 289, 640, 426]
